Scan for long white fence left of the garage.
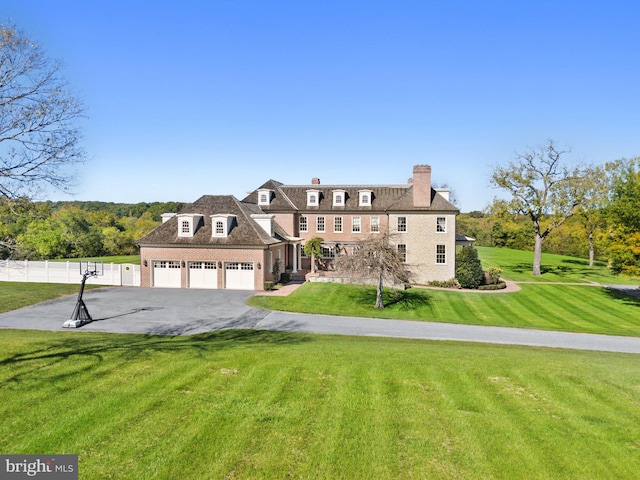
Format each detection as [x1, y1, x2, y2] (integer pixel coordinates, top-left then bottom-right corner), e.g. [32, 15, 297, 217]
[0, 260, 140, 287]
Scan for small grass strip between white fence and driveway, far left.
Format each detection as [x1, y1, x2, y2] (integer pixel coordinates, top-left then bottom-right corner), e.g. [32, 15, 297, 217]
[0, 282, 104, 313]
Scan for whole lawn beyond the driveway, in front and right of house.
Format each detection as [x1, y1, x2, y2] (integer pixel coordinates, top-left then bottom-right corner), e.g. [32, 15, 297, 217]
[249, 247, 640, 336]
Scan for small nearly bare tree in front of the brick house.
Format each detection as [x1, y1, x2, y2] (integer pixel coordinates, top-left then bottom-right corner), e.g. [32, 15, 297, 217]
[336, 235, 409, 308]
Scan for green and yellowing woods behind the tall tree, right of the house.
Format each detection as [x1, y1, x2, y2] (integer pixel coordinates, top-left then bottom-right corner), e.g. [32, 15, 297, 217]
[456, 157, 640, 276]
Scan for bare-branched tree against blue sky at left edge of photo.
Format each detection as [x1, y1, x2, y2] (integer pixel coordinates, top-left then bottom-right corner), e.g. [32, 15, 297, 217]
[0, 24, 84, 199]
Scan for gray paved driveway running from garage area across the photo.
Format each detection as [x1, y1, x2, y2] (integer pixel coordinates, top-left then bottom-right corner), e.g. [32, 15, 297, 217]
[0, 287, 640, 354]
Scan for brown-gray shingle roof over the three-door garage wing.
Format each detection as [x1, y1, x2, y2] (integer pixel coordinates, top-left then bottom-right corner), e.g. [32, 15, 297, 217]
[137, 195, 286, 247]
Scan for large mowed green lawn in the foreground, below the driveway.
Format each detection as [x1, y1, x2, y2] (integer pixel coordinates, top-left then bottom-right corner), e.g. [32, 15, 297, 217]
[0, 330, 640, 479]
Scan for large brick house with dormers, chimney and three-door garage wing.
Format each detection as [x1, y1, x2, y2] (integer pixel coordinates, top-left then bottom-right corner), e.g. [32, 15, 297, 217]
[138, 165, 459, 290]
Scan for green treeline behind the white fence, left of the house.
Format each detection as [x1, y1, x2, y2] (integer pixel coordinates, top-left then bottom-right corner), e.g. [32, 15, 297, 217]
[0, 201, 184, 260]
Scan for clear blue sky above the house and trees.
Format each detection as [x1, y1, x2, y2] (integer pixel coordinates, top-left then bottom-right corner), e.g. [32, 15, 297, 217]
[5, 0, 640, 212]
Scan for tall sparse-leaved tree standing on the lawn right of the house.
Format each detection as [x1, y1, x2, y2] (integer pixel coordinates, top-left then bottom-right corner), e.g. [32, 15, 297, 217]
[490, 140, 584, 276]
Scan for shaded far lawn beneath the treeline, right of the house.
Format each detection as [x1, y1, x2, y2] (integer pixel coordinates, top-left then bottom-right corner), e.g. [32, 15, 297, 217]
[477, 247, 640, 286]
